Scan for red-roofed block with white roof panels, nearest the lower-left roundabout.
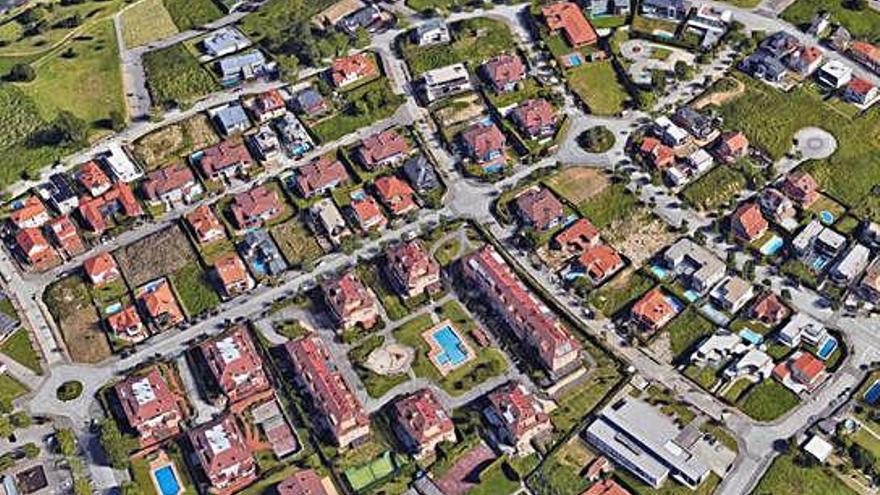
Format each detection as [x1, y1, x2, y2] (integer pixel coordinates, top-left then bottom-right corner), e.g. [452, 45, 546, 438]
[113, 366, 184, 447]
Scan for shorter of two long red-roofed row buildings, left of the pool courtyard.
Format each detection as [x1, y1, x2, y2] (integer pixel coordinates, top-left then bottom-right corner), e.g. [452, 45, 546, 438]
[284, 335, 370, 448]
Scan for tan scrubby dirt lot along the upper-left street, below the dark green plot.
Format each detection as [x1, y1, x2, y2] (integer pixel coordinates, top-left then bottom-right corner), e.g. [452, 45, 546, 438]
[131, 114, 220, 170]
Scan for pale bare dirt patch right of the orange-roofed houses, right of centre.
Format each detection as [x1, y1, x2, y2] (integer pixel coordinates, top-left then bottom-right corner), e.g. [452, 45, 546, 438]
[603, 209, 675, 266]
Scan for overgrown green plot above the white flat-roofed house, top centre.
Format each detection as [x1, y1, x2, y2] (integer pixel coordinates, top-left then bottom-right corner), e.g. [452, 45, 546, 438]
[402, 17, 516, 76]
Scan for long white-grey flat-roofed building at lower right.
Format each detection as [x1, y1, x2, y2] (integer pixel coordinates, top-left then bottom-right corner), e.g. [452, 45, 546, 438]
[585, 397, 710, 489]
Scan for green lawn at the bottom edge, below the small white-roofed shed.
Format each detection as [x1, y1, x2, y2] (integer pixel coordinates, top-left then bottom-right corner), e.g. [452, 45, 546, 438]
[752, 454, 857, 495]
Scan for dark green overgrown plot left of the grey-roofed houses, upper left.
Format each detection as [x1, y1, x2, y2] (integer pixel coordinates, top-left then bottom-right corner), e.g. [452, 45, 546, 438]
[144, 44, 218, 106]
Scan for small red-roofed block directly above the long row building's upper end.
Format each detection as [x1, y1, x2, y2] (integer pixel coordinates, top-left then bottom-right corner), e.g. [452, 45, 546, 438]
[321, 270, 380, 330]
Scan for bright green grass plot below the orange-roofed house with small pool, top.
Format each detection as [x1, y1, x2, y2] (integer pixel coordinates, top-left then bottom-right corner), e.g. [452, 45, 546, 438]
[565, 60, 629, 115]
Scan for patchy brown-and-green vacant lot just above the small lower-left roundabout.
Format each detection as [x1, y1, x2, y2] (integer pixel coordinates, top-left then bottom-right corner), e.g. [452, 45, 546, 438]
[43, 275, 111, 363]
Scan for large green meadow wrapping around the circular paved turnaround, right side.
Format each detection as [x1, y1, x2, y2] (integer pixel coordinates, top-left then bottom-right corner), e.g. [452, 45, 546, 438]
[719, 76, 880, 220]
